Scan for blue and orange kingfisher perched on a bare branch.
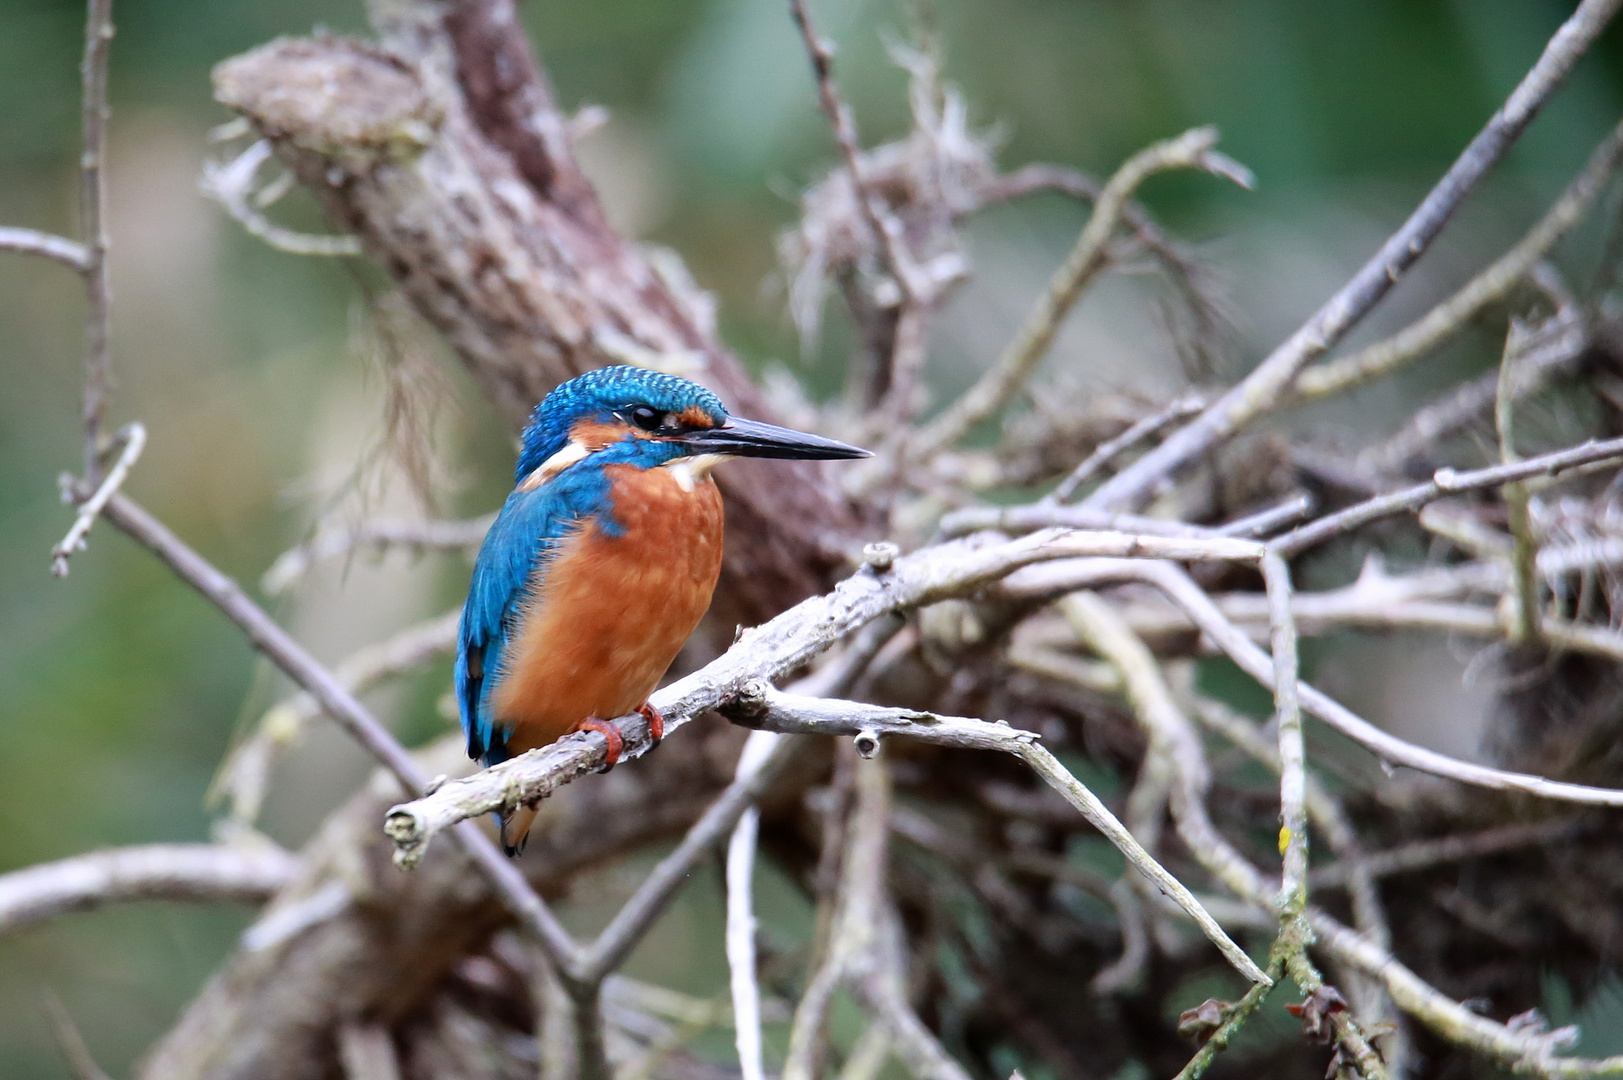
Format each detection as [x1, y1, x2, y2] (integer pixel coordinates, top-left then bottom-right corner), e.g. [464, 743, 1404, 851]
[456, 365, 870, 856]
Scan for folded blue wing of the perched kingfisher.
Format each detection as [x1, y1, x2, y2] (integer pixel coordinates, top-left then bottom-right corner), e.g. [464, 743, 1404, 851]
[456, 466, 609, 767]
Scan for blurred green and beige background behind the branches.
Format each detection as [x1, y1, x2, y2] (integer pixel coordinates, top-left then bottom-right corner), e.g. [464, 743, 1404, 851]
[0, 0, 1623, 1078]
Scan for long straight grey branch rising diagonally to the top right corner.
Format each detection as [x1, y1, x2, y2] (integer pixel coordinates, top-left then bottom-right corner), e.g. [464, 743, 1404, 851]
[1086, 0, 1623, 510]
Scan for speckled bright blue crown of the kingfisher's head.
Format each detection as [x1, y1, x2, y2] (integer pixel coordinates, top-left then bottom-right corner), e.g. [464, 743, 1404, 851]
[513, 364, 727, 484]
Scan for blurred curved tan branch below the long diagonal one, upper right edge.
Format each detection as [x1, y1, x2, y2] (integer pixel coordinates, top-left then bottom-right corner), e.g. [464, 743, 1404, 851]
[1294, 114, 1623, 398]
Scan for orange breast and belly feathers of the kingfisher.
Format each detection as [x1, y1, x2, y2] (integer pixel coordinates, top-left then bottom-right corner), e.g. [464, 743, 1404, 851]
[493, 464, 722, 754]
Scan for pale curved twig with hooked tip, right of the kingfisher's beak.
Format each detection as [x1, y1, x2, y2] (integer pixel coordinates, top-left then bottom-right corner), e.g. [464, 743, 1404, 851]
[907, 127, 1253, 460]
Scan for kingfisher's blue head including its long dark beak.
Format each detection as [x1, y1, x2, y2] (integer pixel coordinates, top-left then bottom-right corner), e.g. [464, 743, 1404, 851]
[514, 365, 868, 484]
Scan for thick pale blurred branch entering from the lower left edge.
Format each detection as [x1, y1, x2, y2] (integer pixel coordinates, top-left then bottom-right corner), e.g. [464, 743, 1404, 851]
[0, 845, 297, 937]
